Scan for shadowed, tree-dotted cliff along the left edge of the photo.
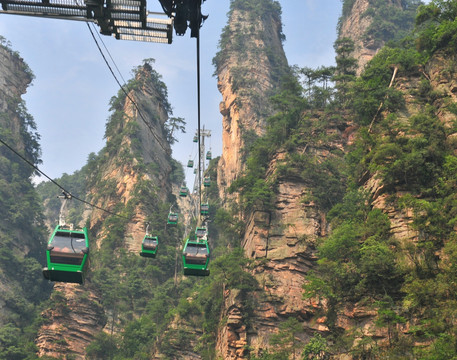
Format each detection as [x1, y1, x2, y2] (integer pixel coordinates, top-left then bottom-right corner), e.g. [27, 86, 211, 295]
[0, 43, 49, 330]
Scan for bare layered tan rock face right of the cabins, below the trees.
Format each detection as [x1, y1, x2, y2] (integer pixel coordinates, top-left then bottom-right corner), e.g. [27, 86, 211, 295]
[218, 114, 347, 360]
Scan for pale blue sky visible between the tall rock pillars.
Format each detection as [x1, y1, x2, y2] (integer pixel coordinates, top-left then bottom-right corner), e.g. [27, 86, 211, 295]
[0, 0, 341, 186]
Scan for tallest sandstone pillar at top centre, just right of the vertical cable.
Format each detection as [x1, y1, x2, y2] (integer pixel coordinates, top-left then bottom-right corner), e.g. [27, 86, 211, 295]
[215, 0, 288, 199]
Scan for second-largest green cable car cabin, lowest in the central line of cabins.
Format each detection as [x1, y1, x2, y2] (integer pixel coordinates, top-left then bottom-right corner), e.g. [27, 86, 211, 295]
[182, 239, 209, 276]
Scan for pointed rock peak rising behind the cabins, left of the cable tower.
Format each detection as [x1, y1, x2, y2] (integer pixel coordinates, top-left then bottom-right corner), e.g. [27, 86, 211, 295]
[90, 64, 171, 253]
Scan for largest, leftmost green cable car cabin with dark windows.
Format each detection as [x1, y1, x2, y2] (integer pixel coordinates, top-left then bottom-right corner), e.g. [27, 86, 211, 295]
[43, 225, 89, 284]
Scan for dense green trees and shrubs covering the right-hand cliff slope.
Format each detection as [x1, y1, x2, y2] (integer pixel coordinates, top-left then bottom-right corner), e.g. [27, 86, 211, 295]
[305, 1, 457, 359]
